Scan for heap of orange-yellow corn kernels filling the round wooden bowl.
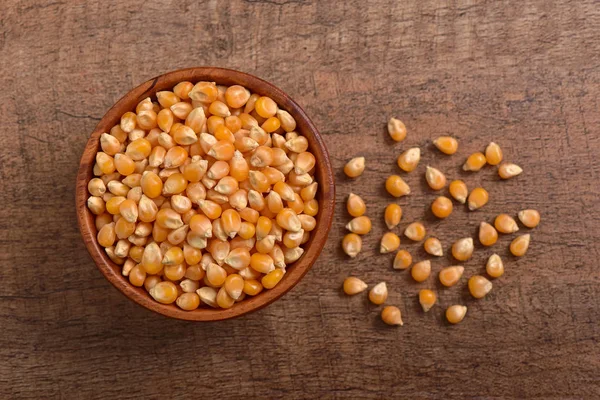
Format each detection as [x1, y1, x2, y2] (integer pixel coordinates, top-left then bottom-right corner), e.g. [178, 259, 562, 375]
[87, 82, 319, 310]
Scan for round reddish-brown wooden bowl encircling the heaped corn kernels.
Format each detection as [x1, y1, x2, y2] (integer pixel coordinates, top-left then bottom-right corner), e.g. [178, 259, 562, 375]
[75, 67, 335, 321]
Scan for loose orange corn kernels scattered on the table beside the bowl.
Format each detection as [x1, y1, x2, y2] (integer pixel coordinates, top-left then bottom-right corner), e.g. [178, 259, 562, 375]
[342, 118, 540, 325]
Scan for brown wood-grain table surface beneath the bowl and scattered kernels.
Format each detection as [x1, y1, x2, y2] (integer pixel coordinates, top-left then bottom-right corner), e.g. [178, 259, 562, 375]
[0, 0, 600, 399]
